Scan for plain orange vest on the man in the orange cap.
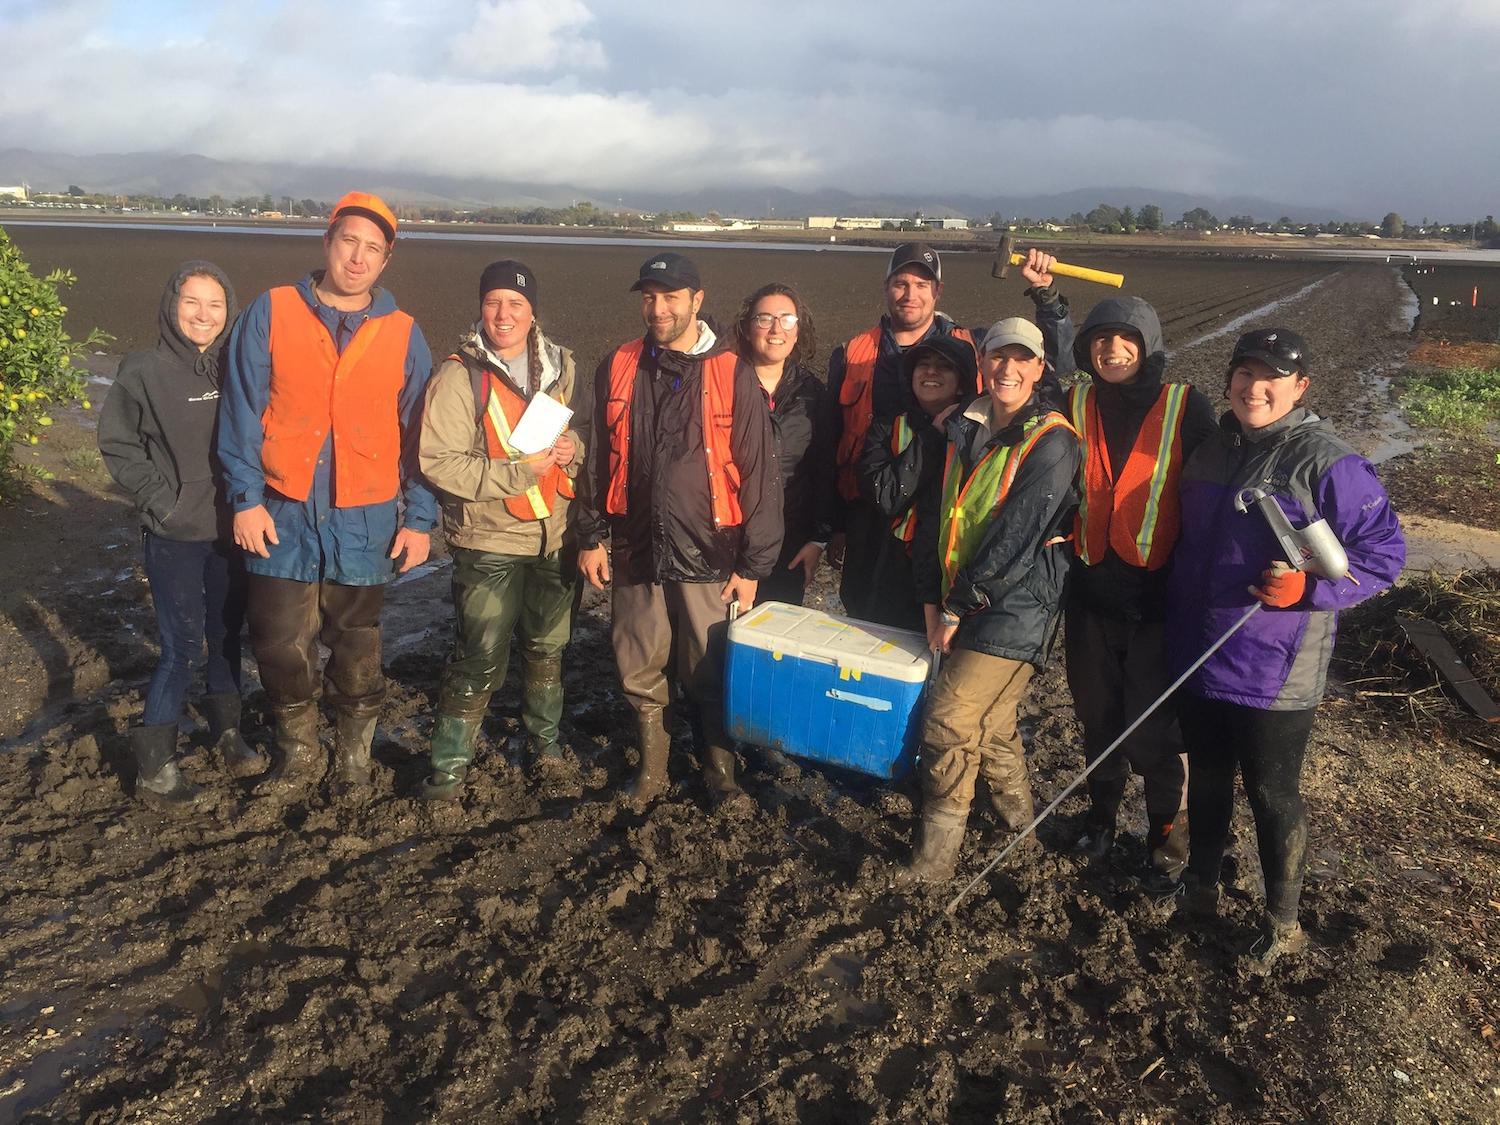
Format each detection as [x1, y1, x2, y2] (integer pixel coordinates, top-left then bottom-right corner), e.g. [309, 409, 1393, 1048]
[261, 285, 413, 509]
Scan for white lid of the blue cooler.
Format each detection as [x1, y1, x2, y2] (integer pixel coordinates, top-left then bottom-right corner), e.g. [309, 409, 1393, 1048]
[729, 602, 932, 684]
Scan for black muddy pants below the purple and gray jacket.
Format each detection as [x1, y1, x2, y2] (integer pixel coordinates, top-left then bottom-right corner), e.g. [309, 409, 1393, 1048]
[1178, 692, 1316, 923]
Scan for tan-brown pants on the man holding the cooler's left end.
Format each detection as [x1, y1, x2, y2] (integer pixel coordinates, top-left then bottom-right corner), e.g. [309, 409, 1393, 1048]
[611, 579, 729, 746]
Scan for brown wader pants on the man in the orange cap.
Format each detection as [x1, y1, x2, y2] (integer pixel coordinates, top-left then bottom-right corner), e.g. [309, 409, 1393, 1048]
[246, 575, 386, 716]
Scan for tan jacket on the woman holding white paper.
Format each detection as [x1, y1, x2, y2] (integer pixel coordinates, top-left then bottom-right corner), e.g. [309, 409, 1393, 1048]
[417, 333, 584, 555]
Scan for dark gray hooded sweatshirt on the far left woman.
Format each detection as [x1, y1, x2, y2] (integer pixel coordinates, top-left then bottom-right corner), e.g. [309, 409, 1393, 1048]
[99, 261, 239, 543]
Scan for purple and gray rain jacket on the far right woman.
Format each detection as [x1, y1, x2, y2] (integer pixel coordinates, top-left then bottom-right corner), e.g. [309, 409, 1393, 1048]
[1167, 408, 1406, 711]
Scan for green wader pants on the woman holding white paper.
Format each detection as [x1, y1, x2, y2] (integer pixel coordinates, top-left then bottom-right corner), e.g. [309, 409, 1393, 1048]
[438, 548, 578, 746]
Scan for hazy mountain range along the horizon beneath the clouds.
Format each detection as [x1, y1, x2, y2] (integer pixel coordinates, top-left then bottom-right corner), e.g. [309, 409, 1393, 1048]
[0, 149, 1379, 222]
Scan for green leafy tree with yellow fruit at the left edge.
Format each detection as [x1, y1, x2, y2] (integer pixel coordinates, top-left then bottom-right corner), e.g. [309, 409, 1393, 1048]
[0, 227, 111, 492]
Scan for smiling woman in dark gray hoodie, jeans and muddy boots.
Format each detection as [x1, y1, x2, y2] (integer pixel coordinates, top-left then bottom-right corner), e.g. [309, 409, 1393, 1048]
[99, 261, 266, 807]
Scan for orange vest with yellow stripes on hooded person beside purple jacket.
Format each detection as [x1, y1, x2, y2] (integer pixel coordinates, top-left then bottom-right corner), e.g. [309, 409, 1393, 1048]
[1068, 383, 1188, 570]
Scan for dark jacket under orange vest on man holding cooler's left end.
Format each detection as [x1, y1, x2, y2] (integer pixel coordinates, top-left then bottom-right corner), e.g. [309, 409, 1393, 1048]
[573, 321, 782, 585]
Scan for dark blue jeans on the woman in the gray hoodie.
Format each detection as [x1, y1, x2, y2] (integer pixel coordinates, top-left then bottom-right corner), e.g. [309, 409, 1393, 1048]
[141, 531, 246, 726]
